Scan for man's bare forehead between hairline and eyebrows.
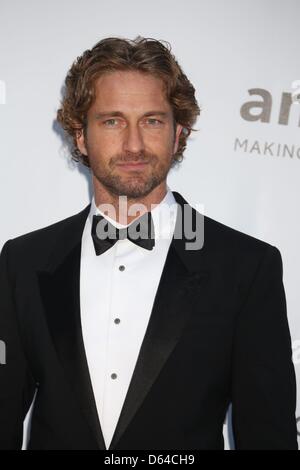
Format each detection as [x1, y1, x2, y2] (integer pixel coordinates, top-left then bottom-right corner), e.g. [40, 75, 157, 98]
[95, 71, 169, 109]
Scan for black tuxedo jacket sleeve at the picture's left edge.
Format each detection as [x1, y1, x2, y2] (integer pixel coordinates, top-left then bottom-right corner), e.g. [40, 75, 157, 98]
[0, 240, 35, 450]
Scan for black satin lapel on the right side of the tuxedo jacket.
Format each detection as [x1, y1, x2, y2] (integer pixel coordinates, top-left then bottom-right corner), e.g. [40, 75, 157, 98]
[109, 192, 209, 450]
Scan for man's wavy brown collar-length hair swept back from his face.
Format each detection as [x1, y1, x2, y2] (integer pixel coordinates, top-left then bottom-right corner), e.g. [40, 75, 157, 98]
[57, 36, 200, 167]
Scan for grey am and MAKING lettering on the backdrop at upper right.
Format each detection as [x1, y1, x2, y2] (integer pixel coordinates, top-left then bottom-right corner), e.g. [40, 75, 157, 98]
[234, 80, 300, 160]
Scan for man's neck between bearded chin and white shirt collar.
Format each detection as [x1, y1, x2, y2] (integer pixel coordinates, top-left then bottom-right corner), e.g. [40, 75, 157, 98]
[93, 179, 167, 225]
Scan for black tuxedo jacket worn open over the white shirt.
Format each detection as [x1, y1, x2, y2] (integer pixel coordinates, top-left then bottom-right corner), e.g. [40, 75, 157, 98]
[0, 192, 297, 450]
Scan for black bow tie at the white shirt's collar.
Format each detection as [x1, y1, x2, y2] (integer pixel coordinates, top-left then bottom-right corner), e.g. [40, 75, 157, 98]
[92, 212, 155, 256]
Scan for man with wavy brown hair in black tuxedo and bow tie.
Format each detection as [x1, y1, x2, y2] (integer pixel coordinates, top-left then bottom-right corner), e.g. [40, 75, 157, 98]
[0, 37, 297, 451]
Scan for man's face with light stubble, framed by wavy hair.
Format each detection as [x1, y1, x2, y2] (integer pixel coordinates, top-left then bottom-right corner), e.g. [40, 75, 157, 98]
[77, 71, 182, 199]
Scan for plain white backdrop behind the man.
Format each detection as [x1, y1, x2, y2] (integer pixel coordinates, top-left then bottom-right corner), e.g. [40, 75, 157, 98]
[0, 0, 300, 447]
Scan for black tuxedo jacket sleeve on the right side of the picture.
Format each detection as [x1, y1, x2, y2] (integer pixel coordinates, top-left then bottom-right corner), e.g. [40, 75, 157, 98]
[232, 245, 298, 450]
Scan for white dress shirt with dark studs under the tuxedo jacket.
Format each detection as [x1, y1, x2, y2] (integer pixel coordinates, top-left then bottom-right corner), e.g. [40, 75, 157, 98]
[80, 187, 177, 449]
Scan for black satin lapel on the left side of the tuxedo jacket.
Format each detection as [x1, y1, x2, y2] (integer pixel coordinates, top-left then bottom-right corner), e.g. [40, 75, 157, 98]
[38, 206, 105, 450]
